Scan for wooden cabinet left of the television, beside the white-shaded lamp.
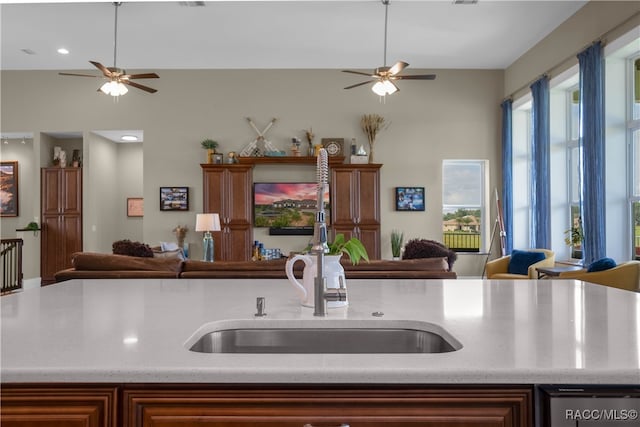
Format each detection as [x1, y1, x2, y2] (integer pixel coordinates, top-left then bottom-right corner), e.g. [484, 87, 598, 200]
[201, 164, 253, 261]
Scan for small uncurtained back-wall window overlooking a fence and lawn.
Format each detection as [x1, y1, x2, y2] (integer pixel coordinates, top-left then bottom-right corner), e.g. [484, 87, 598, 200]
[442, 160, 489, 252]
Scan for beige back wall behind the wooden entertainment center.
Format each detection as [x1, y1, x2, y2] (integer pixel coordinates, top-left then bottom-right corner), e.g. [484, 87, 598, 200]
[2, 70, 503, 275]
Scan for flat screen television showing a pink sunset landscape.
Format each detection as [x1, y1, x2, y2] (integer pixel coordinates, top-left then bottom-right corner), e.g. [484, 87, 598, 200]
[253, 182, 330, 235]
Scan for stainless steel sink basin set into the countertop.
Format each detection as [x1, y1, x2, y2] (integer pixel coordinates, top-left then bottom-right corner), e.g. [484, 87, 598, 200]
[187, 321, 462, 354]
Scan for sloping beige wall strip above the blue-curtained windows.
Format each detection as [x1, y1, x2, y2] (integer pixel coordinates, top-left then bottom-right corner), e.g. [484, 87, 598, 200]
[504, 0, 640, 98]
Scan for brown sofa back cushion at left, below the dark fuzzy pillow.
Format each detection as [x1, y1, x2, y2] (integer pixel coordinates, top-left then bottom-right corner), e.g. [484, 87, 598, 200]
[71, 252, 182, 273]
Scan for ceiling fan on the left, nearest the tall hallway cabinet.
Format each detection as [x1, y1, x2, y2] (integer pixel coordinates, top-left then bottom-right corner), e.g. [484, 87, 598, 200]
[58, 2, 160, 96]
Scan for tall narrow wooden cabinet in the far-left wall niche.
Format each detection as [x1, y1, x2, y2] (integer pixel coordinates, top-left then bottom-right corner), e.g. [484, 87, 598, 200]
[40, 168, 82, 285]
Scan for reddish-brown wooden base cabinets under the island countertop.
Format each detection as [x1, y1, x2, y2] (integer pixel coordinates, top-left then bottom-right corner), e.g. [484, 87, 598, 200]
[0, 384, 533, 427]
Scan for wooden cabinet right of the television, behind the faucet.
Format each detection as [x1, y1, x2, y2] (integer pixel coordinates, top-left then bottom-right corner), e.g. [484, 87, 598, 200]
[330, 164, 382, 259]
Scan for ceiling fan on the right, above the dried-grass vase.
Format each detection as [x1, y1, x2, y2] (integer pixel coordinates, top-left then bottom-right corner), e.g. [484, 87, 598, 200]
[342, 0, 436, 96]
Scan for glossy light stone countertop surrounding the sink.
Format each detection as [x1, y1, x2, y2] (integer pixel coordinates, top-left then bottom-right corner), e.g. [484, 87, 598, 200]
[0, 279, 640, 384]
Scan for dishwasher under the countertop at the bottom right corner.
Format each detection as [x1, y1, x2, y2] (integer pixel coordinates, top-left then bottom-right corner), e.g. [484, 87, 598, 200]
[536, 384, 640, 427]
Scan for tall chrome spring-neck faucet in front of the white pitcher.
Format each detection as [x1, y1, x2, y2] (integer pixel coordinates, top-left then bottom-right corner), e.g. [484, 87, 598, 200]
[311, 148, 347, 316]
